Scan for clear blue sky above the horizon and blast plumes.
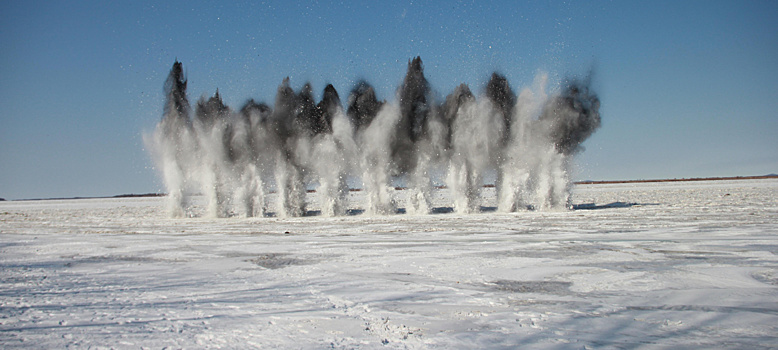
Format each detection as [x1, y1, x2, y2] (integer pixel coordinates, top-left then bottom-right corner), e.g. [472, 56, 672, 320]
[0, 0, 778, 199]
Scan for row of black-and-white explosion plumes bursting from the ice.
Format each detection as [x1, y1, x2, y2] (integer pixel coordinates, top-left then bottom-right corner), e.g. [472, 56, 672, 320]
[145, 57, 600, 217]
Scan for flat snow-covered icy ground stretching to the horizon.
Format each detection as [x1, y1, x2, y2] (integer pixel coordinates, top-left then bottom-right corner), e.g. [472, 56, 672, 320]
[0, 179, 778, 349]
